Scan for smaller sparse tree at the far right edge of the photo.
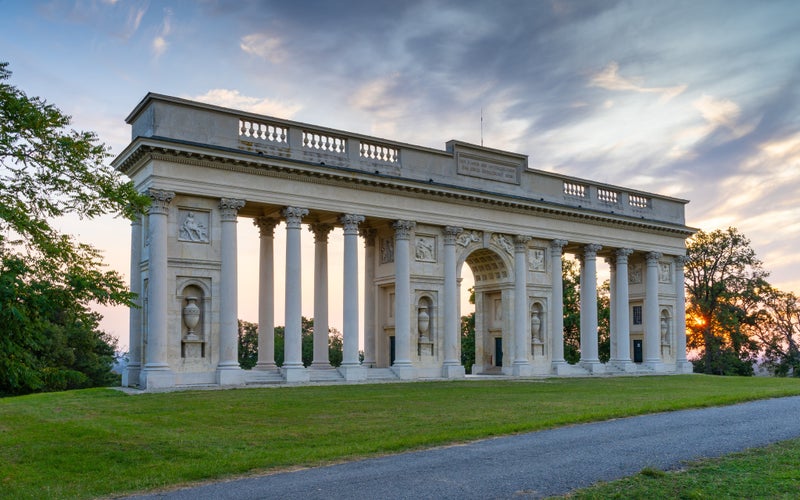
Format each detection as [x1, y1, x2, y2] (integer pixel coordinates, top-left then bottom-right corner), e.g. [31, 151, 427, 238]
[756, 288, 800, 377]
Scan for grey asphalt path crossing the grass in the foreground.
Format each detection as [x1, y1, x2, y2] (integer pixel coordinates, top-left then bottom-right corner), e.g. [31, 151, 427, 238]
[131, 396, 800, 500]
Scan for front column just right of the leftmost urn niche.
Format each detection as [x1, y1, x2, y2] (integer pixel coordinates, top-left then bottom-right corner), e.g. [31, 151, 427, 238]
[217, 198, 245, 385]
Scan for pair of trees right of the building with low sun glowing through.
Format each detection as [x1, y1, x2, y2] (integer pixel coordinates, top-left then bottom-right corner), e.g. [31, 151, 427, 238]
[685, 227, 800, 376]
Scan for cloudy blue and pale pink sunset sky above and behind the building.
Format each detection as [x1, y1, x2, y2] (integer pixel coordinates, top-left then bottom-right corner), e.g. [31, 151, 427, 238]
[0, 0, 800, 347]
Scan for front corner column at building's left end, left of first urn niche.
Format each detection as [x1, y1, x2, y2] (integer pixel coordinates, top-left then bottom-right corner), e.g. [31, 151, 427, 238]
[139, 189, 175, 389]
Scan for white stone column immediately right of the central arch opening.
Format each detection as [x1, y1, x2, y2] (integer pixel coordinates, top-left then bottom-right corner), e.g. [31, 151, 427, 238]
[511, 235, 532, 377]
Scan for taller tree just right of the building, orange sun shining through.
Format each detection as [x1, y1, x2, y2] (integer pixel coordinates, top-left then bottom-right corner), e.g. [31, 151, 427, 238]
[686, 227, 769, 375]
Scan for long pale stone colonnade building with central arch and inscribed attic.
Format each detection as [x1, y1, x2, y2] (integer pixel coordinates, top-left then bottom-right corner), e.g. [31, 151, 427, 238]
[114, 94, 693, 389]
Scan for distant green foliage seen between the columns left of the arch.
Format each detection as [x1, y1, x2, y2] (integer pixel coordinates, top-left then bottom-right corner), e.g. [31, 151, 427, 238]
[239, 316, 342, 370]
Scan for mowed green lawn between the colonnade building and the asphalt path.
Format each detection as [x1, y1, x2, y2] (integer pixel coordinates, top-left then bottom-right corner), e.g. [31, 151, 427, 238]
[0, 375, 800, 498]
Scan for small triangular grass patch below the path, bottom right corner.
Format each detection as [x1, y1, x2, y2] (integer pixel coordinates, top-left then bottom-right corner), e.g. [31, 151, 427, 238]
[567, 439, 800, 500]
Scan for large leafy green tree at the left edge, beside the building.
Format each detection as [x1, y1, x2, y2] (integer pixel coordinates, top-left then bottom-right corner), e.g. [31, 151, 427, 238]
[0, 63, 148, 395]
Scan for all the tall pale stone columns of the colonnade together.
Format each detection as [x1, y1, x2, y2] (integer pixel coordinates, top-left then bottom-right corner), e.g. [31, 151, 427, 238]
[124, 189, 686, 387]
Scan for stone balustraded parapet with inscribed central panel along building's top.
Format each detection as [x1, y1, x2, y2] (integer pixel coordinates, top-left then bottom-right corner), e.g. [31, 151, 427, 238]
[128, 94, 687, 225]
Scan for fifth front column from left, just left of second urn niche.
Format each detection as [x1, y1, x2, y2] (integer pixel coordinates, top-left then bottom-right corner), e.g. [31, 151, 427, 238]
[392, 220, 416, 379]
